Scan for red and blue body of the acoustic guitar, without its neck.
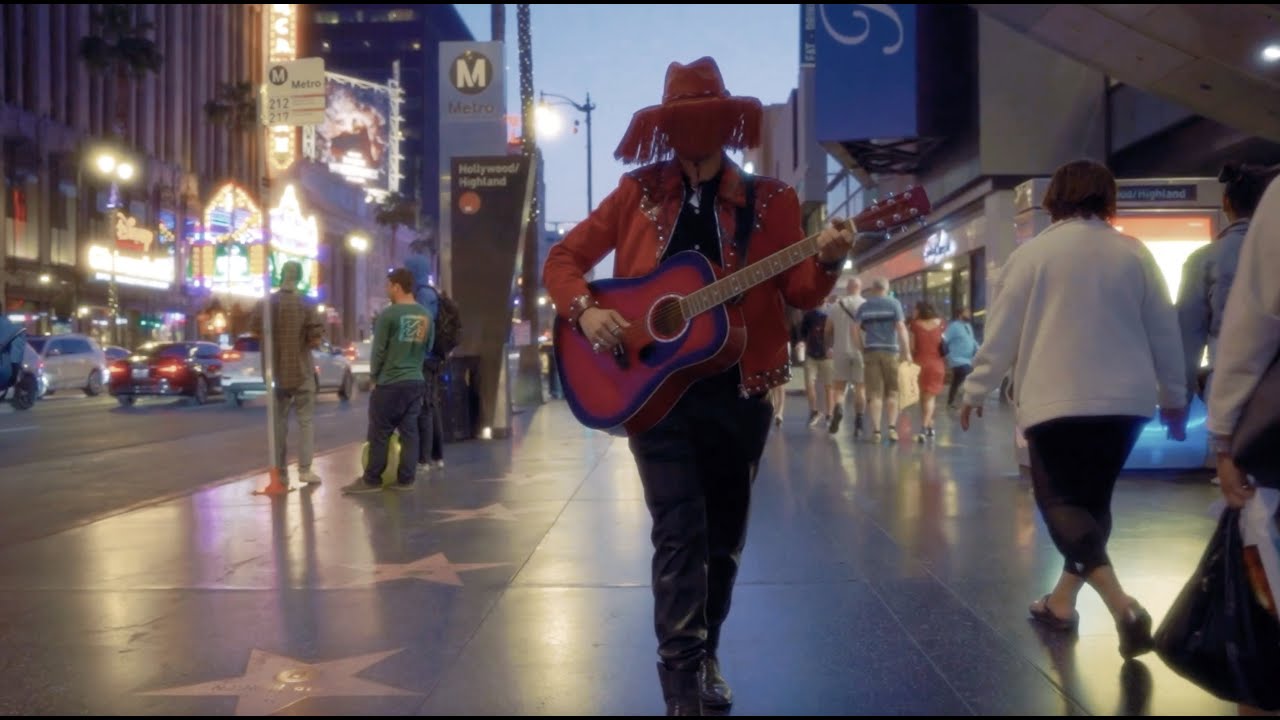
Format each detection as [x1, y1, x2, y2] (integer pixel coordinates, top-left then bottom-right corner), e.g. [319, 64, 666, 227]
[553, 252, 746, 434]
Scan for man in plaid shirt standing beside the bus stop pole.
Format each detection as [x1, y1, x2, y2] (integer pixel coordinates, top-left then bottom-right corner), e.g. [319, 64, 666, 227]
[253, 260, 324, 486]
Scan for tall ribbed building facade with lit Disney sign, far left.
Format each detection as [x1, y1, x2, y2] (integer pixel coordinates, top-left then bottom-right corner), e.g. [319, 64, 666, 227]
[0, 4, 264, 345]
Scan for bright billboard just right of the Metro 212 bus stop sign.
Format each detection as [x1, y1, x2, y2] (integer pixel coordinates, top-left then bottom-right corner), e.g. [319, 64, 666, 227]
[303, 73, 401, 197]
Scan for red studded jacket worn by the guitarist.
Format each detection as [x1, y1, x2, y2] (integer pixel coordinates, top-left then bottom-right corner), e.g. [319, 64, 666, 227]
[543, 159, 840, 395]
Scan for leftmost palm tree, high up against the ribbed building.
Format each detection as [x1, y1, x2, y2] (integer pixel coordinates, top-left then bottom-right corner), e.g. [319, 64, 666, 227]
[79, 5, 164, 138]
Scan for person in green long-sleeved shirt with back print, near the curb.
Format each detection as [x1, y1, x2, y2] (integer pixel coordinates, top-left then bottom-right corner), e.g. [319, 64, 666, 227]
[342, 268, 431, 495]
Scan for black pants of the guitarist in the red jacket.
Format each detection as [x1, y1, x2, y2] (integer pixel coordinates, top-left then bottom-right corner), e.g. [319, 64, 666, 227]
[631, 370, 773, 670]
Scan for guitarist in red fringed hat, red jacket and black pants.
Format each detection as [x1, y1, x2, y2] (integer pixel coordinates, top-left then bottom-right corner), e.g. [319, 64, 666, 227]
[543, 58, 852, 715]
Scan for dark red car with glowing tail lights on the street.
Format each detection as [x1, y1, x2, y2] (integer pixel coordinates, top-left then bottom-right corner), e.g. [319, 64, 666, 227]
[109, 342, 223, 407]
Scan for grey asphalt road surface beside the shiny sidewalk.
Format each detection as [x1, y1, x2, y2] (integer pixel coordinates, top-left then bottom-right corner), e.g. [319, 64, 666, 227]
[0, 393, 367, 546]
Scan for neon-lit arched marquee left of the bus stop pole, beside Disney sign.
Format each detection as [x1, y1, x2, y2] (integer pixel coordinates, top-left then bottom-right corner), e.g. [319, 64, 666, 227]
[187, 183, 266, 297]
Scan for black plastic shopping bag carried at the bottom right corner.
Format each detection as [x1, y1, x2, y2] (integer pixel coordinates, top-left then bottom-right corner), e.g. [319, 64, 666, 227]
[1156, 509, 1280, 710]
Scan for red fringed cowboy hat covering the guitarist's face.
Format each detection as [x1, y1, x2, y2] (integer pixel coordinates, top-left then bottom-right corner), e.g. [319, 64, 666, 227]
[613, 58, 764, 163]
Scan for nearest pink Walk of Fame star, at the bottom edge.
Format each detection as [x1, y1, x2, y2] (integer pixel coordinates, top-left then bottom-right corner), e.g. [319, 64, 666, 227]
[138, 650, 422, 715]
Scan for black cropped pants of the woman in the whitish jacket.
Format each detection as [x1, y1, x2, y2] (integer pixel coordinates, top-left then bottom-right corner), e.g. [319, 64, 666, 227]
[1025, 416, 1147, 578]
